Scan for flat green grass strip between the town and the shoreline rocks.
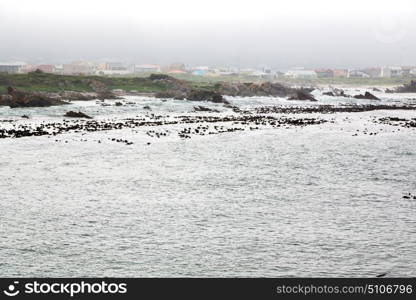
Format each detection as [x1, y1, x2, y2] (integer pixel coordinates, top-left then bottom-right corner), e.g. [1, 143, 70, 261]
[0, 72, 411, 93]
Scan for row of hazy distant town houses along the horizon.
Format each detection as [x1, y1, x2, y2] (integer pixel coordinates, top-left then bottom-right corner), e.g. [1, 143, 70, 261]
[0, 61, 416, 79]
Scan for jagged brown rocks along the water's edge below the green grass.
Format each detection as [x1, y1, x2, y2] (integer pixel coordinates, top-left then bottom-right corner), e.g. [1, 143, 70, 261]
[0, 74, 317, 108]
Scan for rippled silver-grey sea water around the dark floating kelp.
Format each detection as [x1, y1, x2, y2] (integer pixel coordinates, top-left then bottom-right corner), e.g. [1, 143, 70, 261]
[0, 91, 416, 277]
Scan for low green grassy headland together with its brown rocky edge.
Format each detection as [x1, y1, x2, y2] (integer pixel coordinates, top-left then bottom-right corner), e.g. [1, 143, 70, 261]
[0, 71, 316, 107]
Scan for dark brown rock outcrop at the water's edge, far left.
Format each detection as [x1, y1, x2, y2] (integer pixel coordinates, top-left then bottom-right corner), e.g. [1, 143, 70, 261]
[0, 86, 68, 108]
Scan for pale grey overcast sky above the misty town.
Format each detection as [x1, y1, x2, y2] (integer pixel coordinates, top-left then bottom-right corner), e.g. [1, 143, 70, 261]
[0, 0, 416, 68]
